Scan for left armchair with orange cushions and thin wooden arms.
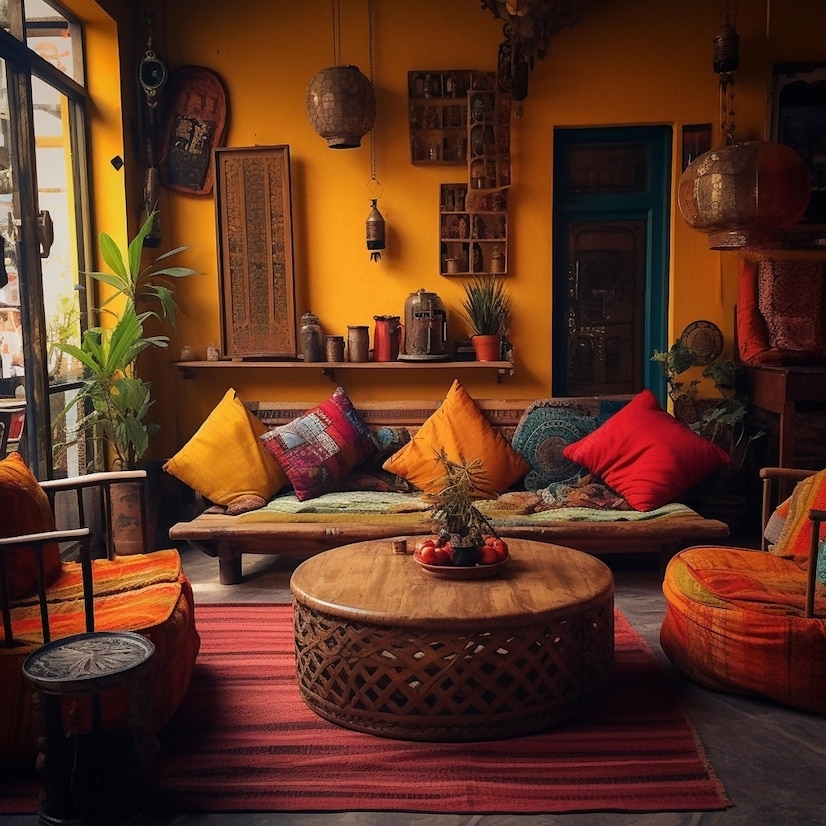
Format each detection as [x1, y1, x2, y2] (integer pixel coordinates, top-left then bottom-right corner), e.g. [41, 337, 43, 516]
[0, 453, 200, 800]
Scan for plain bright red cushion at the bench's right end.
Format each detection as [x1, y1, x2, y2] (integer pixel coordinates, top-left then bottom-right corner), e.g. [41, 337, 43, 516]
[562, 390, 729, 511]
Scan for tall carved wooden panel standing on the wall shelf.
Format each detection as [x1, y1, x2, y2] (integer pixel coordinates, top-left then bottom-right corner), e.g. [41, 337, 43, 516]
[215, 145, 298, 359]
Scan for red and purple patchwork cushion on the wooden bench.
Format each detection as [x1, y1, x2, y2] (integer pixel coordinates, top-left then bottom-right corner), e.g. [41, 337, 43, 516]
[261, 387, 376, 501]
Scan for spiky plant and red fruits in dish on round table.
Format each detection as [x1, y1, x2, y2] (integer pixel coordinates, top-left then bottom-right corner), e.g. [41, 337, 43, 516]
[415, 450, 508, 567]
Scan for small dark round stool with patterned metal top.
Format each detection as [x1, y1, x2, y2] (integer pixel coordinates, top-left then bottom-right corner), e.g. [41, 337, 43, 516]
[23, 631, 158, 826]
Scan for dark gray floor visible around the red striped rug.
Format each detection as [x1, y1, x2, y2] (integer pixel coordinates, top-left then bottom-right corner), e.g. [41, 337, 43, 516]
[0, 549, 826, 826]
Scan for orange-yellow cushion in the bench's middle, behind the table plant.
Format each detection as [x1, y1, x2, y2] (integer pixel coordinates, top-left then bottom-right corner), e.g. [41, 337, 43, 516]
[382, 381, 530, 493]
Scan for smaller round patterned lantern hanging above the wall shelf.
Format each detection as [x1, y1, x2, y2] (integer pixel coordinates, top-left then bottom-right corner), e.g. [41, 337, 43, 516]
[306, 66, 376, 149]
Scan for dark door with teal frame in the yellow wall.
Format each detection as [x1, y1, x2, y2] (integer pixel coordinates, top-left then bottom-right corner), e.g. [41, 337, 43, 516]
[551, 126, 672, 401]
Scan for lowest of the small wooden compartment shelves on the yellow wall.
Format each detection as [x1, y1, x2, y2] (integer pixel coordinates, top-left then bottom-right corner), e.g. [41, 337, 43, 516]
[439, 183, 508, 275]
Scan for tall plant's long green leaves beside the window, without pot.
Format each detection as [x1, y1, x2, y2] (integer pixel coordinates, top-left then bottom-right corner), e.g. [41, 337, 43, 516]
[56, 212, 197, 470]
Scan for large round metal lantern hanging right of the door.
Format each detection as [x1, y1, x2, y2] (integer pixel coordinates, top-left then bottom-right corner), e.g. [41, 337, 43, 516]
[677, 141, 811, 250]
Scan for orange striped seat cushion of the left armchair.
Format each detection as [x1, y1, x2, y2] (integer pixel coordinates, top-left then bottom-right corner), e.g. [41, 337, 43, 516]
[0, 550, 200, 765]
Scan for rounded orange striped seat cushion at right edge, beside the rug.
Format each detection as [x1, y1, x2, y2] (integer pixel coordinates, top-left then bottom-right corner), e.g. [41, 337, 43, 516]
[660, 547, 826, 714]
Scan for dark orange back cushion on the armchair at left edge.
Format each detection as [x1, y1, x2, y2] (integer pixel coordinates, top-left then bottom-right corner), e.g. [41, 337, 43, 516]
[0, 453, 60, 600]
